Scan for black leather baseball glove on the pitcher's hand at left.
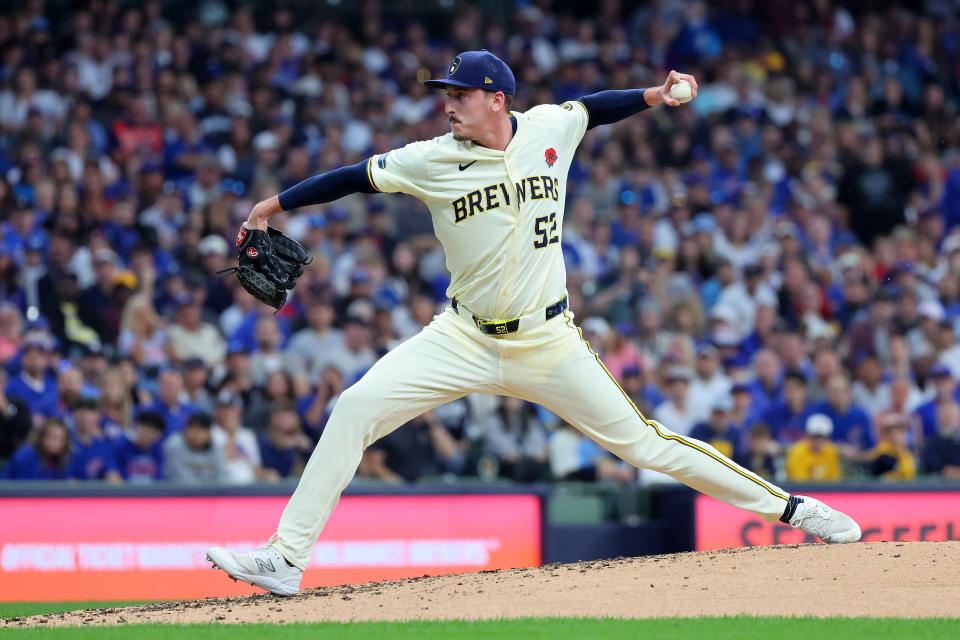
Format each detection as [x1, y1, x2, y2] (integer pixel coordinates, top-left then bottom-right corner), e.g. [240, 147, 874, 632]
[220, 226, 311, 309]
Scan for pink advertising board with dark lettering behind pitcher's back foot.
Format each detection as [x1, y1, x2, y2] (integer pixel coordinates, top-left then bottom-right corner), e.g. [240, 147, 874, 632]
[695, 491, 960, 551]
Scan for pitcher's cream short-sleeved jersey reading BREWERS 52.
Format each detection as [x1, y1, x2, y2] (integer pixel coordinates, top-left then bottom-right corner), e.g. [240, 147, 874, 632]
[367, 102, 588, 319]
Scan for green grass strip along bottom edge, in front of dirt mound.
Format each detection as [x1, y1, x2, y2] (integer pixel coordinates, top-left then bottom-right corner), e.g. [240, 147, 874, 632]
[0, 616, 960, 640]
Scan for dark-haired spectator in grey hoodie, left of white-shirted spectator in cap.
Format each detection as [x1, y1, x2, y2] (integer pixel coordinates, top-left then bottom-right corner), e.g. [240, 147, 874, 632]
[163, 413, 226, 484]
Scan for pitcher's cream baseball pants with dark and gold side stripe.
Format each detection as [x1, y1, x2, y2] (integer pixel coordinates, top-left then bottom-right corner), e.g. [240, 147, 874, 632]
[272, 307, 788, 569]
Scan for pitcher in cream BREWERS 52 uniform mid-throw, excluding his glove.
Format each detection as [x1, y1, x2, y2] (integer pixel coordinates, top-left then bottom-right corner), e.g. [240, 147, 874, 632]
[207, 50, 860, 595]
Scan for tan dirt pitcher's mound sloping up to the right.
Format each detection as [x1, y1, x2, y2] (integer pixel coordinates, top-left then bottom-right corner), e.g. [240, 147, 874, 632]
[0, 542, 960, 629]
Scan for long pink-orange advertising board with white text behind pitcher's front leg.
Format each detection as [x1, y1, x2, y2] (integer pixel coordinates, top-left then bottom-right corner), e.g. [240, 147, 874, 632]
[0, 495, 541, 602]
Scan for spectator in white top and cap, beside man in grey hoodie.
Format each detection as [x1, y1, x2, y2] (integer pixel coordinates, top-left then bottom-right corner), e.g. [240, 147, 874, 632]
[212, 389, 266, 484]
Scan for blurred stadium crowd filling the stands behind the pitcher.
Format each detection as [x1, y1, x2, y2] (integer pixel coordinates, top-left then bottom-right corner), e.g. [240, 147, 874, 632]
[0, 0, 960, 483]
